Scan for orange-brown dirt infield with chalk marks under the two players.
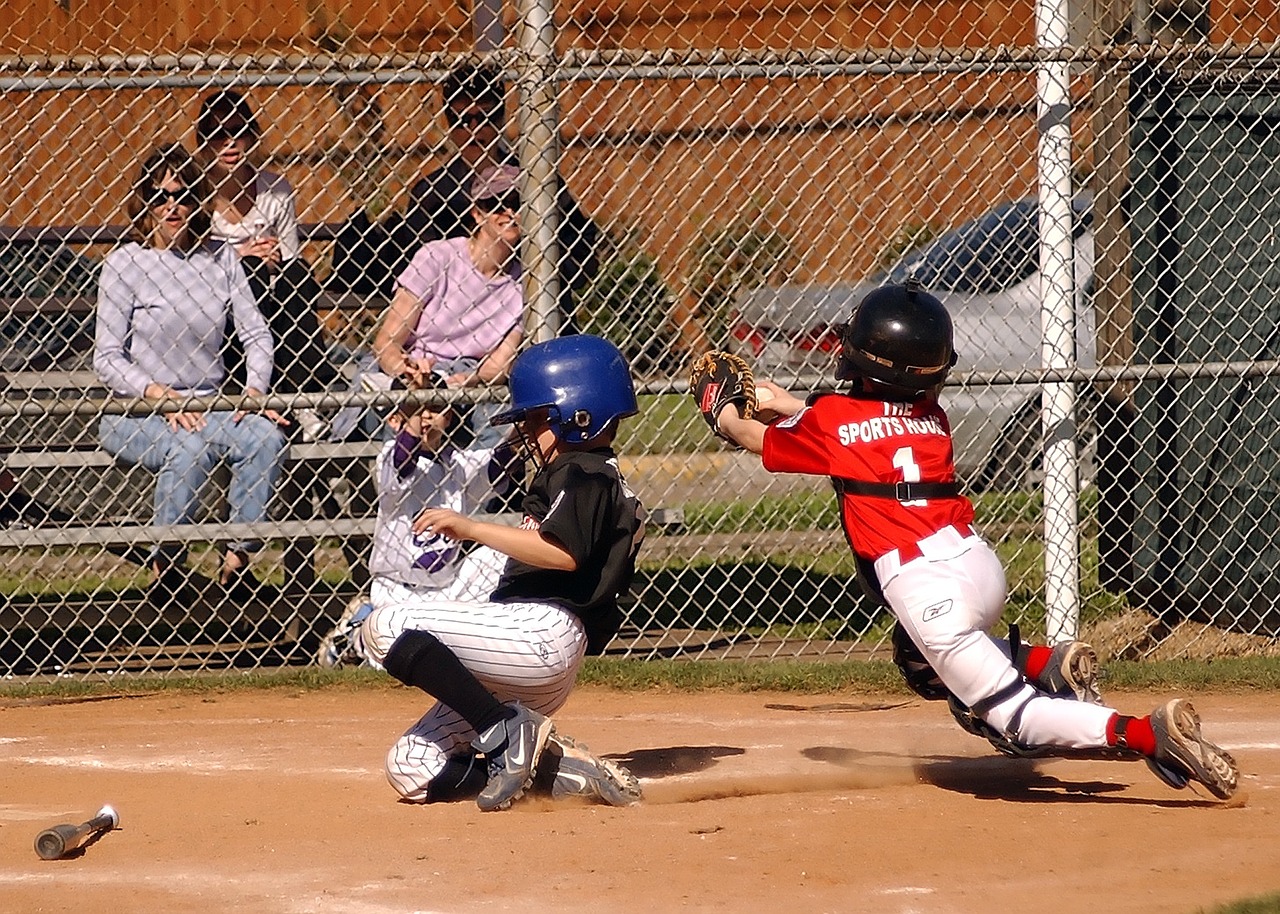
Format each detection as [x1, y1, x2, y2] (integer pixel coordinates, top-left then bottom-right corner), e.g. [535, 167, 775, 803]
[0, 689, 1280, 914]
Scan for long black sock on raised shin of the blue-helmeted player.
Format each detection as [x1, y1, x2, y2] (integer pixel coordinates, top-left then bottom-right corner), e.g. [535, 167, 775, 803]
[383, 630, 516, 734]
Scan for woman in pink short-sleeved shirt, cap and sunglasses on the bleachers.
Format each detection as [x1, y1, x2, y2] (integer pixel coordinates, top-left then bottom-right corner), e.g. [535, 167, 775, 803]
[374, 165, 525, 447]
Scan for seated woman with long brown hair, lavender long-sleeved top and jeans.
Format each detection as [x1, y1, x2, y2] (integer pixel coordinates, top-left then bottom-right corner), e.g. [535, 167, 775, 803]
[93, 143, 285, 594]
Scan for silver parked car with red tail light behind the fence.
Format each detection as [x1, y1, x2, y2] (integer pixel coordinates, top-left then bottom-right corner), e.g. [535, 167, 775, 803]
[731, 196, 1096, 489]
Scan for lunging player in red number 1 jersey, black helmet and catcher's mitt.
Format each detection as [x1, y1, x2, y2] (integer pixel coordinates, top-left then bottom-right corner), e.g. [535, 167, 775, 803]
[690, 282, 1238, 800]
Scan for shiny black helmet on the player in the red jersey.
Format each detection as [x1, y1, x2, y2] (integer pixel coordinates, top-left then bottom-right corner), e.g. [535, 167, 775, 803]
[836, 279, 956, 398]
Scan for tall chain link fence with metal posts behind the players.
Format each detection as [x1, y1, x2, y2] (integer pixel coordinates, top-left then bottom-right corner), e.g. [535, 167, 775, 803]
[0, 0, 1280, 677]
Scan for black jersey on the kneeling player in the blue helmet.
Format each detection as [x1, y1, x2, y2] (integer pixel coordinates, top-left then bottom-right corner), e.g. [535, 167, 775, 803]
[492, 448, 645, 654]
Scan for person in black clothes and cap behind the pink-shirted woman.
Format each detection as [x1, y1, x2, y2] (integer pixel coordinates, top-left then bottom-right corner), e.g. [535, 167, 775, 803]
[329, 61, 600, 333]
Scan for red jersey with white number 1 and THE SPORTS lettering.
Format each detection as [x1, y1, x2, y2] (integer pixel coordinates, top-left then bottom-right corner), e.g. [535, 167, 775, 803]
[762, 394, 973, 561]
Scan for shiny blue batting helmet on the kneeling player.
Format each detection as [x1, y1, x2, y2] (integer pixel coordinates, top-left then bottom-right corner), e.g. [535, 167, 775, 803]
[489, 334, 637, 443]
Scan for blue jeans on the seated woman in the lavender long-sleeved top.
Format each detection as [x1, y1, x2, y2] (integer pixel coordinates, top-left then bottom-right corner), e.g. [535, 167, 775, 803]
[99, 412, 284, 556]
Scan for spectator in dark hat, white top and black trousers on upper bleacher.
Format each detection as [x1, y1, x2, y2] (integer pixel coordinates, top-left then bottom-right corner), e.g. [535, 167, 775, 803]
[196, 90, 339, 440]
